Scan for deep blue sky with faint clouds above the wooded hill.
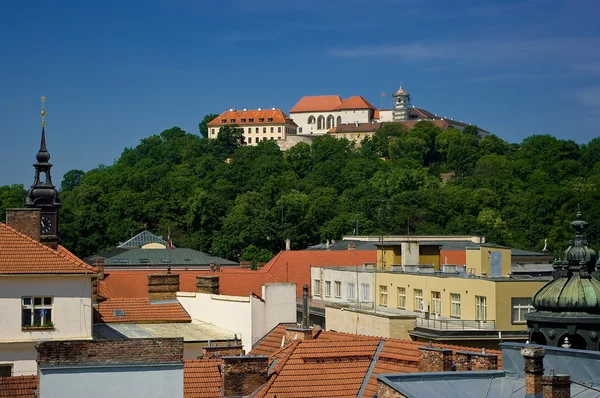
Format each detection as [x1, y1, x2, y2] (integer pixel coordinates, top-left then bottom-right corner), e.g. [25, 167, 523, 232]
[0, 0, 600, 187]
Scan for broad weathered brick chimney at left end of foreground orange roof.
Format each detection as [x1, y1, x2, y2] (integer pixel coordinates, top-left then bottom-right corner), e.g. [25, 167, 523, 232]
[221, 355, 269, 397]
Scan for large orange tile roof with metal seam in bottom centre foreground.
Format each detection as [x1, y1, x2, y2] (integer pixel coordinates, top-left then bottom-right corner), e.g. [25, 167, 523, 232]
[249, 325, 502, 398]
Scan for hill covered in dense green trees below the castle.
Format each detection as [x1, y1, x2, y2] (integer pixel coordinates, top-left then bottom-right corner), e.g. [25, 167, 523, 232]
[0, 122, 600, 260]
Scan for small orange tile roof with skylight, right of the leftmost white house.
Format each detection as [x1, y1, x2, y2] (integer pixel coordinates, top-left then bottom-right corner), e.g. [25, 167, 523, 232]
[98, 298, 192, 323]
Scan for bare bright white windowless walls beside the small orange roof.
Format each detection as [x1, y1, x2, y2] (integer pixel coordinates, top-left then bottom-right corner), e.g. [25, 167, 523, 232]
[177, 283, 296, 352]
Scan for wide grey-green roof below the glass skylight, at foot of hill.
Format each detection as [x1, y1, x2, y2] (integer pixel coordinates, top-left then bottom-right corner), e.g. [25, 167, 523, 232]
[105, 248, 237, 266]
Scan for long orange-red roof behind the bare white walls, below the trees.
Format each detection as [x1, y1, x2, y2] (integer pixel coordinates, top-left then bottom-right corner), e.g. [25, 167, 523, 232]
[100, 250, 377, 298]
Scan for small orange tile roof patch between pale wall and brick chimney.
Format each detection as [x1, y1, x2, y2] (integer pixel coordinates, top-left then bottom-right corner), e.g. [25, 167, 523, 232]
[183, 359, 223, 398]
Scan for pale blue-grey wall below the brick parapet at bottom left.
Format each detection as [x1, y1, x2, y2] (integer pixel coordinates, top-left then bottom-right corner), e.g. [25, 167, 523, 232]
[40, 364, 183, 398]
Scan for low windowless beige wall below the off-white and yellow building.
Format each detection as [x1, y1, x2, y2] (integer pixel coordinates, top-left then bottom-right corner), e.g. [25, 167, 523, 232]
[325, 306, 415, 340]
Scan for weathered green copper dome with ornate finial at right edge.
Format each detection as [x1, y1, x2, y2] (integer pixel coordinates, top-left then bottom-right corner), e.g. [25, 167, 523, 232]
[533, 212, 600, 314]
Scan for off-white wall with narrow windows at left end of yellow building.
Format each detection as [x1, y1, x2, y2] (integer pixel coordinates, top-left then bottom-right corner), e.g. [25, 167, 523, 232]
[310, 266, 375, 303]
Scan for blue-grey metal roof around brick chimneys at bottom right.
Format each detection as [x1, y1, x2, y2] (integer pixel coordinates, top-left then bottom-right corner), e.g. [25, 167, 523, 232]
[378, 343, 600, 398]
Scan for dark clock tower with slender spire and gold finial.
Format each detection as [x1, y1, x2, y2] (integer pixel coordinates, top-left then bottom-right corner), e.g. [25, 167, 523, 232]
[25, 97, 61, 249]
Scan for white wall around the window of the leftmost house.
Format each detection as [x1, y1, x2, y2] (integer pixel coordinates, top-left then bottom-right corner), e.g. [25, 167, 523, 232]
[0, 275, 92, 343]
